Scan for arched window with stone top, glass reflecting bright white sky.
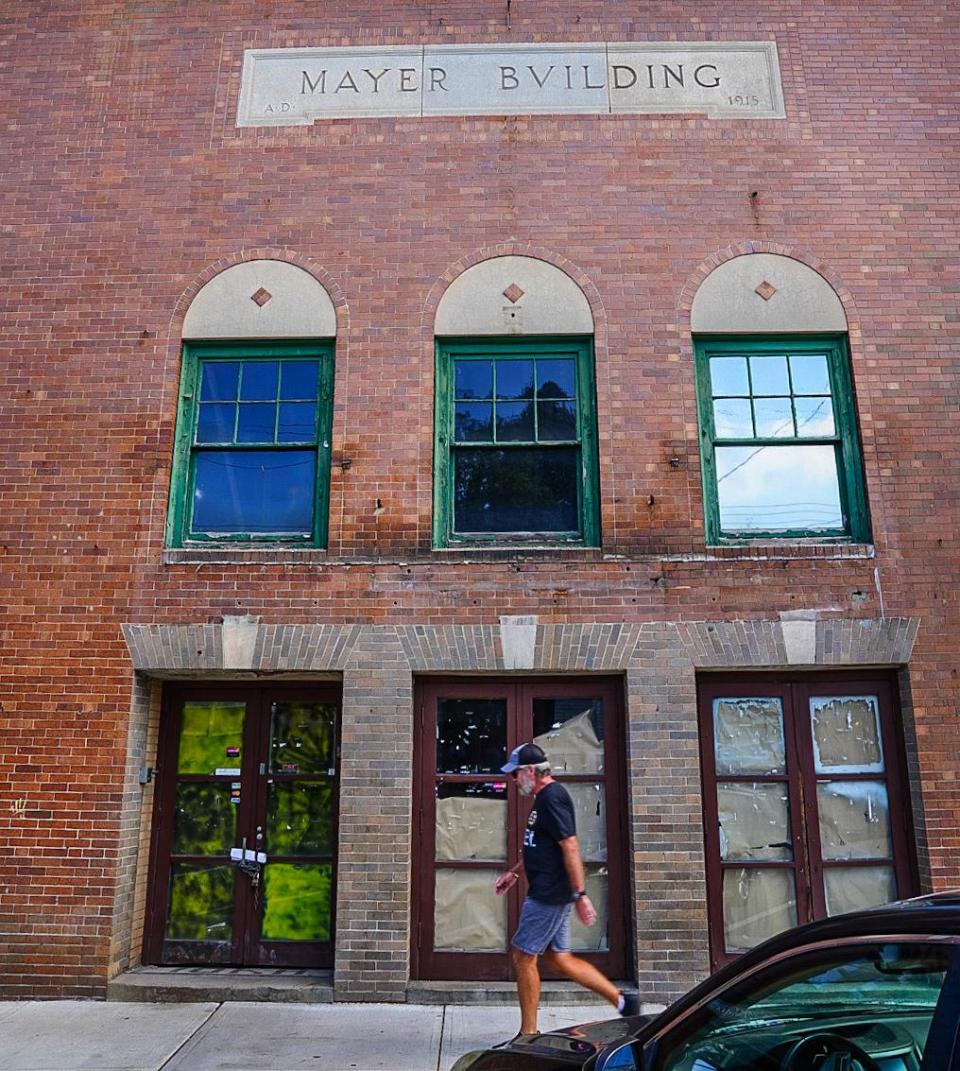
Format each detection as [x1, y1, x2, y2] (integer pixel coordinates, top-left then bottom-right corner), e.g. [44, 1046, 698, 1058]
[691, 253, 870, 544]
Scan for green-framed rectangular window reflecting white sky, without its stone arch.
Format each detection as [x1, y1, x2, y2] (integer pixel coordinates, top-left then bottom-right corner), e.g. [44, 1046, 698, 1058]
[693, 335, 870, 544]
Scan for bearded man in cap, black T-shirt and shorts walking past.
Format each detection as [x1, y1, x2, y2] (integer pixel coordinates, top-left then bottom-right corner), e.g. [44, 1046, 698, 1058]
[494, 743, 640, 1036]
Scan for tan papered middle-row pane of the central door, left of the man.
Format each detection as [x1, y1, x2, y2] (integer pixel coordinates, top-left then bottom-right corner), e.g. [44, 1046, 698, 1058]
[435, 781, 507, 860]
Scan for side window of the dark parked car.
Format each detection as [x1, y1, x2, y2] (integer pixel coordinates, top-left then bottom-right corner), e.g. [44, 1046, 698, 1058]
[653, 941, 954, 1071]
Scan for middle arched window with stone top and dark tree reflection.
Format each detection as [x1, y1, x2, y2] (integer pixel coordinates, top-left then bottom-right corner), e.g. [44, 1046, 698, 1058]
[434, 256, 600, 547]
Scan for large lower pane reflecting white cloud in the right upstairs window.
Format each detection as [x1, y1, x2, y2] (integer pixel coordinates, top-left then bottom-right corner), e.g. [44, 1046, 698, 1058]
[715, 446, 843, 533]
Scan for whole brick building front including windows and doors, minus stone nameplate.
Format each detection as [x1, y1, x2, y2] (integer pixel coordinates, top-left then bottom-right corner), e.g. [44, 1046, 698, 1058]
[0, 0, 960, 1000]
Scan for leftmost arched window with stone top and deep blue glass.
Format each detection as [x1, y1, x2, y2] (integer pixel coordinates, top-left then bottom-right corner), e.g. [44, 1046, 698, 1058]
[167, 260, 336, 546]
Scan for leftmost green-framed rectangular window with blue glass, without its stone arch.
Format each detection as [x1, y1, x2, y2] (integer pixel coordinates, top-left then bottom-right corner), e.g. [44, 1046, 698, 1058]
[166, 341, 333, 547]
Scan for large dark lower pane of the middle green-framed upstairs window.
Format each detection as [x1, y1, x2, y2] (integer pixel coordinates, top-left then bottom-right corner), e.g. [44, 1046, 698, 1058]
[453, 447, 580, 532]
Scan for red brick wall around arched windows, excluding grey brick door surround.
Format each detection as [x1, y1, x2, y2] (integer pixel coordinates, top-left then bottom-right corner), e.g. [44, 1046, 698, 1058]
[0, 0, 960, 996]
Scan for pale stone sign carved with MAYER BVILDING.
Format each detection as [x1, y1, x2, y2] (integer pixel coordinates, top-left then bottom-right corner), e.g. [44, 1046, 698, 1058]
[237, 41, 785, 126]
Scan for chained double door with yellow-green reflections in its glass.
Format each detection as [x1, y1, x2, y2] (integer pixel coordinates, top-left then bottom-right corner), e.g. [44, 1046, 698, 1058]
[145, 684, 339, 966]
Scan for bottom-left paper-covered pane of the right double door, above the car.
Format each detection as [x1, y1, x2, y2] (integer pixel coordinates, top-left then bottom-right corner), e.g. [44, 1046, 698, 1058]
[723, 866, 797, 952]
